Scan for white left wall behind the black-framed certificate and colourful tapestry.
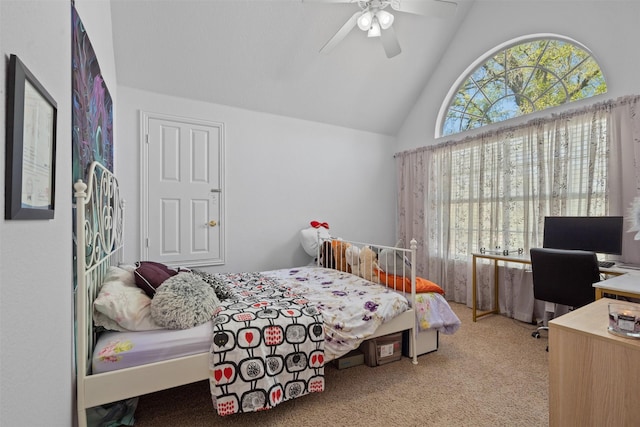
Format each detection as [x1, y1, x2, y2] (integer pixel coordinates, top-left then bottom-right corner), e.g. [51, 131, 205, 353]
[0, 0, 115, 426]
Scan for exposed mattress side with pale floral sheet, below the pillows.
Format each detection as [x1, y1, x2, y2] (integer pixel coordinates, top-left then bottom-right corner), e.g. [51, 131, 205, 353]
[91, 322, 213, 374]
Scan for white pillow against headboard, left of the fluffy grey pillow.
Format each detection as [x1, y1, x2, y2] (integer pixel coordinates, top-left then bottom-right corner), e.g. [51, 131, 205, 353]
[93, 266, 162, 331]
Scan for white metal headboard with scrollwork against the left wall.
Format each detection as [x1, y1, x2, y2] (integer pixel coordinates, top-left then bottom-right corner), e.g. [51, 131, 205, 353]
[73, 162, 124, 382]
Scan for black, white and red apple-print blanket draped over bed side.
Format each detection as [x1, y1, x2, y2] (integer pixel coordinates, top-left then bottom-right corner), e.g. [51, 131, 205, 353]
[209, 273, 325, 415]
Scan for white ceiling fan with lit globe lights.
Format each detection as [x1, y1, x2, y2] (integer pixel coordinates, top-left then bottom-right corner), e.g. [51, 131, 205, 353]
[312, 0, 457, 58]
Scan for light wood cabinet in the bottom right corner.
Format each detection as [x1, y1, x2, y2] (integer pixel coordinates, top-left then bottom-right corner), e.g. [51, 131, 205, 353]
[549, 298, 640, 427]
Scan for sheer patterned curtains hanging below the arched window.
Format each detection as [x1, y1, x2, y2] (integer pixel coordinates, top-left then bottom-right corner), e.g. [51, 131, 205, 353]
[396, 97, 640, 321]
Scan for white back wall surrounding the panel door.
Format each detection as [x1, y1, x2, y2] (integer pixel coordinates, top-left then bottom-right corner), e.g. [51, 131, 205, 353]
[116, 87, 395, 271]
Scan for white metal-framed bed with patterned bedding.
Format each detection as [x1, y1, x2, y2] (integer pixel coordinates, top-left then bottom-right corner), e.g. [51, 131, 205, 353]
[74, 162, 459, 426]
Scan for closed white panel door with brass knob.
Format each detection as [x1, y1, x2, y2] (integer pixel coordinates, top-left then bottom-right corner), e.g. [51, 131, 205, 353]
[141, 113, 224, 266]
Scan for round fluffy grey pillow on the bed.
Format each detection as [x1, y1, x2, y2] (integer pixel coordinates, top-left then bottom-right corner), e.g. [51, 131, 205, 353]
[151, 272, 220, 329]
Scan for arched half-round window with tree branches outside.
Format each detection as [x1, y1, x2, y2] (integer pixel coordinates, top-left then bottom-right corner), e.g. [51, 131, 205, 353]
[436, 35, 607, 136]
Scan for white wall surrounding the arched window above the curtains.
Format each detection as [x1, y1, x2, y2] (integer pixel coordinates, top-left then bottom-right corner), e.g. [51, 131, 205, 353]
[396, 0, 640, 151]
